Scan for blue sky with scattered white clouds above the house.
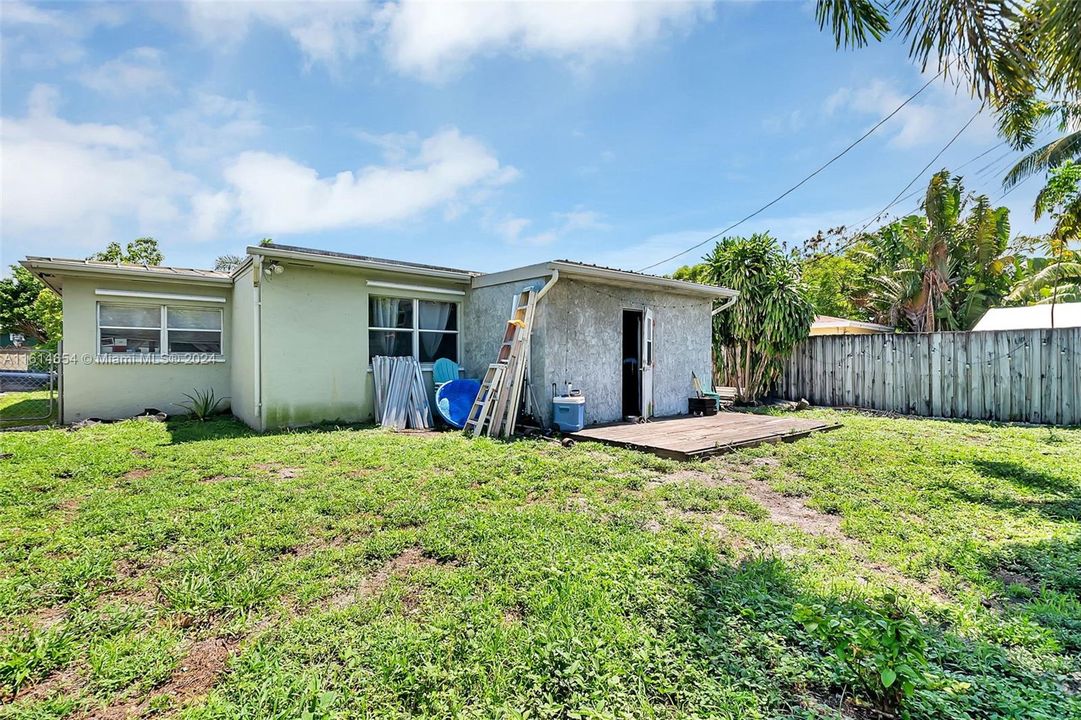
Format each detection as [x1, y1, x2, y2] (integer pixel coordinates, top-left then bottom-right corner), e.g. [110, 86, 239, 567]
[0, 0, 1040, 271]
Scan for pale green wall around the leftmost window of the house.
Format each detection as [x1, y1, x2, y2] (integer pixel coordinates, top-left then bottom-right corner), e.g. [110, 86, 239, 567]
[63, 277, 233, 423]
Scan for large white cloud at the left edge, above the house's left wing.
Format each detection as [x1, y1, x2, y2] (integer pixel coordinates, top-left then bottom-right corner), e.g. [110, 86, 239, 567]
[0, 85, 198, 245]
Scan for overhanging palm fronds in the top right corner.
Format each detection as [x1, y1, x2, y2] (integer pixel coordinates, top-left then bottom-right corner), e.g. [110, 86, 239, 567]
[816, 0, 1081, 224]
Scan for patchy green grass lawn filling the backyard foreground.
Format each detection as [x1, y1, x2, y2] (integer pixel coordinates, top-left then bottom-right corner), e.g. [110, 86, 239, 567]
[0, 411, 1081, 720]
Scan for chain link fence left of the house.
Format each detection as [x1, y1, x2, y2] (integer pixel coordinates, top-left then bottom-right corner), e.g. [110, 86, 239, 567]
[0, 348, 59, 429]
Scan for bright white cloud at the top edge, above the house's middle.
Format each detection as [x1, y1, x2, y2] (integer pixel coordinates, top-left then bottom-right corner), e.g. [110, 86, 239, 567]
[378, 0, 710, 79]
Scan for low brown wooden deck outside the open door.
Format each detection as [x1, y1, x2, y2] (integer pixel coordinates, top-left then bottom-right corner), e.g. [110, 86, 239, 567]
[570, 412, 841, 459]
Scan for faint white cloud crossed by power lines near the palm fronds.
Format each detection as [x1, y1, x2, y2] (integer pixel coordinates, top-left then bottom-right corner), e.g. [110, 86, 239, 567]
[823, 79, 996, 149]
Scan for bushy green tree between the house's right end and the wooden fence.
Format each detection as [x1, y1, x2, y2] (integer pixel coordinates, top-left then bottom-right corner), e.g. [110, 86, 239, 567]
[705, 234, 814, 402]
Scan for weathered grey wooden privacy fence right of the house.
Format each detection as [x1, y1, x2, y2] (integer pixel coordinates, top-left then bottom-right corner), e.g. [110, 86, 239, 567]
[778, 328, 1081, 425]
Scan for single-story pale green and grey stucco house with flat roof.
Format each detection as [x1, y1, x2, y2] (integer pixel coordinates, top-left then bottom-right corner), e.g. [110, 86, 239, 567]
[22, 243, 737, 430]
